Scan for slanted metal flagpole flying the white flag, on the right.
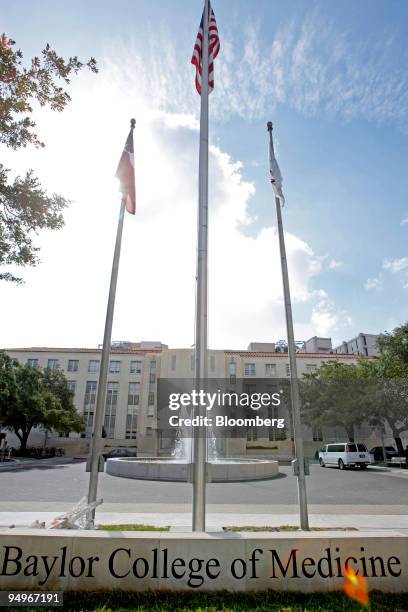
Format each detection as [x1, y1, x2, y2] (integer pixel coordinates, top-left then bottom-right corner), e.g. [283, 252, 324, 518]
[267, 121, 309, 530]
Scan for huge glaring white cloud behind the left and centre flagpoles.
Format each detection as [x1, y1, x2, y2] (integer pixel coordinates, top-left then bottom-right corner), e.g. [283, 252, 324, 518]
[0, 55, 348, 348]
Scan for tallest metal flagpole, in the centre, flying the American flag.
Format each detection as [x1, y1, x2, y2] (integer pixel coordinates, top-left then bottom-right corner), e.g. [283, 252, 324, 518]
[192, 0, 209, 531]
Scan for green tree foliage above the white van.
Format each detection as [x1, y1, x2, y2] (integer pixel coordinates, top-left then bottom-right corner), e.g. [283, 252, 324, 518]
[300, 323, 408, 454]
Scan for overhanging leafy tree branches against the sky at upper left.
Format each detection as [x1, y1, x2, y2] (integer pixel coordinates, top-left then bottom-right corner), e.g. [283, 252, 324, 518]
[0, 34, 97, 282]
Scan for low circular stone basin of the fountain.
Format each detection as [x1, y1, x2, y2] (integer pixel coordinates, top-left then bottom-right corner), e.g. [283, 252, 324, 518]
[106, 457, 279, 482]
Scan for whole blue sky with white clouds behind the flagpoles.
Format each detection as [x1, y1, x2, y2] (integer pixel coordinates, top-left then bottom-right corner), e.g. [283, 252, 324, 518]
[0, 0, 408, 349]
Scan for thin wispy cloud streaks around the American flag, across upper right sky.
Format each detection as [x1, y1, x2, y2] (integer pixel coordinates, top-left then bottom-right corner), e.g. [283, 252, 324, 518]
[84, 9, 408, 129]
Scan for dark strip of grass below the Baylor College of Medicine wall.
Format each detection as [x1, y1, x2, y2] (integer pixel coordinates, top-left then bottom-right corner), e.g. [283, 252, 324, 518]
[7, 591, 408, 612]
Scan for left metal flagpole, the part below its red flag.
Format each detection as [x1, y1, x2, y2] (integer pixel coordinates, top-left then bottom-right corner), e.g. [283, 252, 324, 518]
[88, 198, 125, 528]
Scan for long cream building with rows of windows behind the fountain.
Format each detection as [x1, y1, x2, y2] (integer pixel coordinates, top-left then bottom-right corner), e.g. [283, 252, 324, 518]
[7, 338, 392, 455]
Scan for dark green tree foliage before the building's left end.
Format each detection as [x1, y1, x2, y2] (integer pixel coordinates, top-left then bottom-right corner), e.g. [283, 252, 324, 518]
[0, 352, 84, 450]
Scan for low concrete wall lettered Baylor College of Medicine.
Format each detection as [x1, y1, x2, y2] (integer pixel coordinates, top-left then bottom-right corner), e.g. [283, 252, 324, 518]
[0, 529, 408, 593]
